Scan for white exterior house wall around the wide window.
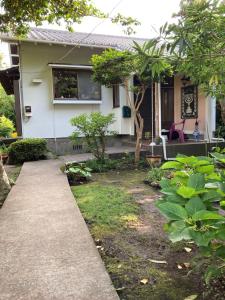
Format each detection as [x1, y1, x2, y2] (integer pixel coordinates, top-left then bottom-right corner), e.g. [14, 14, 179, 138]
[20, 42, 133, 138]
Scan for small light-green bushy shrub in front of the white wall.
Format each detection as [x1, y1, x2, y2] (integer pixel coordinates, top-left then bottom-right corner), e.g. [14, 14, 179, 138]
[71, 112, 115, 161]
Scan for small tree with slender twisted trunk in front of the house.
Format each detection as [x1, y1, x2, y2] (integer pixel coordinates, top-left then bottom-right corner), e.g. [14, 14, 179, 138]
[91, 42, 172, 162]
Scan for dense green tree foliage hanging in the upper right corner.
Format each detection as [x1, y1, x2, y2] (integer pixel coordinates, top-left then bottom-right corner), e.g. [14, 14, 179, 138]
[157, 0, 225, 99]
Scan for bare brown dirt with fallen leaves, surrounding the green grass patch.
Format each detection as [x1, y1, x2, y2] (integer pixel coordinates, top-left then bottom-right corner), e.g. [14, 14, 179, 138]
[75, 171, 221, 300]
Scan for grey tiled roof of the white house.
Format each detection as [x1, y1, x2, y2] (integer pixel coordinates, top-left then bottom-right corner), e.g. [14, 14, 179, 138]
[0, 28, 148, 50]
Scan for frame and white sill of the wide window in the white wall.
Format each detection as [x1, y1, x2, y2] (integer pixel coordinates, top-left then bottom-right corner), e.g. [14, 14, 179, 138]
[48, 64, 102, 104]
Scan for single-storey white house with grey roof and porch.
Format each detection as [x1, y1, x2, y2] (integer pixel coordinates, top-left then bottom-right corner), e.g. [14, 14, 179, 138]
[0, 28, 218, 153]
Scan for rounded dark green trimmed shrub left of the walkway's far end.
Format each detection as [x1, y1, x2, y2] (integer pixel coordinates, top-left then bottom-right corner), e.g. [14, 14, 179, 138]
[9, 138, 47, 164]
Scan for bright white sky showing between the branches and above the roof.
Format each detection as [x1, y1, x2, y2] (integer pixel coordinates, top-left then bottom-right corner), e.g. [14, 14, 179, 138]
[0, 0, 180, 63]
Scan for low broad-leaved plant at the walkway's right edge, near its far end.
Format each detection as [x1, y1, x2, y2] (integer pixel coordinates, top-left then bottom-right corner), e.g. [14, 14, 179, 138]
[64, 162, 92, 184]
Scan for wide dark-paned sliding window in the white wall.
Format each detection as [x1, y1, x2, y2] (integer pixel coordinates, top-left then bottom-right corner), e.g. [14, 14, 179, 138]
[52, 68, 101, 100]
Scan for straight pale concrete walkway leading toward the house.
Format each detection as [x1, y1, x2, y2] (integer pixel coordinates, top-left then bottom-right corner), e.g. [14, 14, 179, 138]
[0, 160, 119, 300]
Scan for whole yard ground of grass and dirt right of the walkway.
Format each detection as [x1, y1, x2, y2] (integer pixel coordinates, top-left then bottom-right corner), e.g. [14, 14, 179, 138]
[72, 170, 218, 300]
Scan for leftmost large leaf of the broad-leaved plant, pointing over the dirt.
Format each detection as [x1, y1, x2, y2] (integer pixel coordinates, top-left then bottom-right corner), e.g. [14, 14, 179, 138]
[157, 202, 188, 220]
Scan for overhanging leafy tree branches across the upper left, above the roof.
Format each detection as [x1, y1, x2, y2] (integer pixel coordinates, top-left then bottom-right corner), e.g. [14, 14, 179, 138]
[0, 0, 140, 35]
